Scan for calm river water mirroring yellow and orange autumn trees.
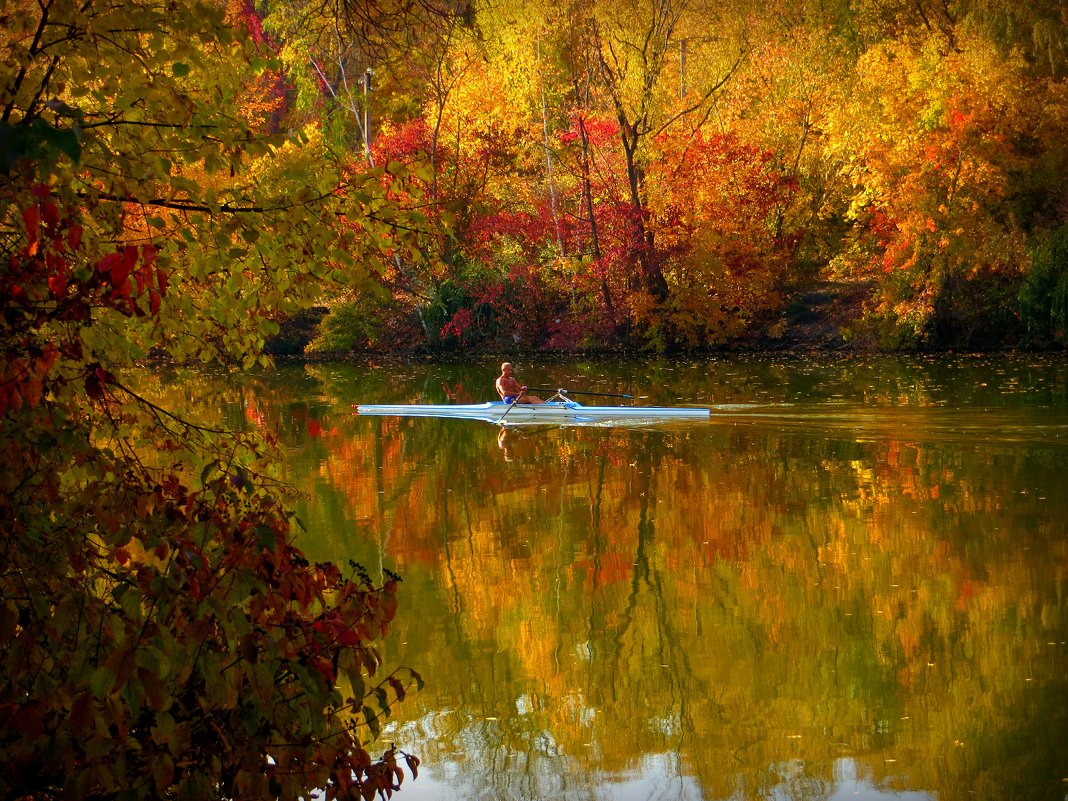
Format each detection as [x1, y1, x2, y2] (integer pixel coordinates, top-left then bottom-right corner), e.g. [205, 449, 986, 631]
[144, 357, 1068, 801]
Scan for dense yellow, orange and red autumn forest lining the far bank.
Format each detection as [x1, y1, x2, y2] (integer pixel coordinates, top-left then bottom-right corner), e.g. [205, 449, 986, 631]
[256, 0, 1068, 350]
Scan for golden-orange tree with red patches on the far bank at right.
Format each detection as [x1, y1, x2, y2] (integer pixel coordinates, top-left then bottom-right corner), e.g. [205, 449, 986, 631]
[815, 24, 1063, 346]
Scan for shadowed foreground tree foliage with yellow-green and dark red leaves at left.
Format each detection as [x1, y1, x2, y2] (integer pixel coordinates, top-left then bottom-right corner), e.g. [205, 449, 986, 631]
[0, 0, 418, 799]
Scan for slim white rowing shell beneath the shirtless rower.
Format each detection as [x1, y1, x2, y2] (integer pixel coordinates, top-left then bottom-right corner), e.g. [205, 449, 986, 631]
[354, 399, 710, 425]
